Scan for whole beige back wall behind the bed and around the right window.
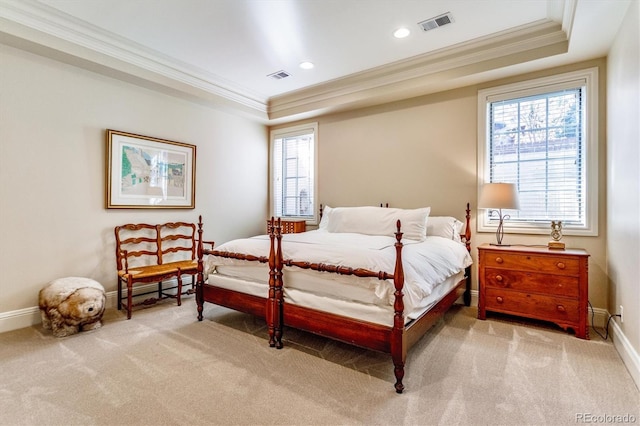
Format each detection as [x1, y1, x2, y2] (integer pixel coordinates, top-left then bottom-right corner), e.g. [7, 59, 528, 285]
[278, 59, 608, 314]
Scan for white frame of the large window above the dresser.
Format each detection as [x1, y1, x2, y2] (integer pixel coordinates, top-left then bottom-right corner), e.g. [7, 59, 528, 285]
[477, 68, 599, 236]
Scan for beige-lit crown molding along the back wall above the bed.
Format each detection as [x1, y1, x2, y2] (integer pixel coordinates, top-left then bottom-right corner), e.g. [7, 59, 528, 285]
[269, 19, 568, 119]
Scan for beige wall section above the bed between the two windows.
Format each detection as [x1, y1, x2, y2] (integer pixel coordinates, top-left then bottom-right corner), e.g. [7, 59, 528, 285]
[318, 88, 477, 213]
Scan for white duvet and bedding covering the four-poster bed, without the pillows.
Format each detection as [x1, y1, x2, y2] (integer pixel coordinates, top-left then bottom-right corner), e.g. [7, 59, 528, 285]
[205, 231, 471, 312]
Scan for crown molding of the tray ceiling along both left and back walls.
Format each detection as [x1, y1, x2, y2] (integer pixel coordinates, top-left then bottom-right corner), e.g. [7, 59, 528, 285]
[0, 0, 576, 124]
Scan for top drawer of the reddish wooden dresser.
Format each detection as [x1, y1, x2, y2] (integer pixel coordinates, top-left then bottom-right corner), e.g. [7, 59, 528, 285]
[484, 252, 580, 275]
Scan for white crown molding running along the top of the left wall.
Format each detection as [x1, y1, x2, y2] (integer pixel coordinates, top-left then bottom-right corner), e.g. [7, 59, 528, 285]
[0, 0, 267, 118]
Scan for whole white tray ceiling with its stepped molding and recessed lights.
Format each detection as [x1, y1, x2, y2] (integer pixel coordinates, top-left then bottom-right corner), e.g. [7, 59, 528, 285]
[0, 0, 630, 123]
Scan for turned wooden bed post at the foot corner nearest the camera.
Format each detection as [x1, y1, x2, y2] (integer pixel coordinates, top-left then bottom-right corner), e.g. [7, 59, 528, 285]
[390, 220, 407, 393]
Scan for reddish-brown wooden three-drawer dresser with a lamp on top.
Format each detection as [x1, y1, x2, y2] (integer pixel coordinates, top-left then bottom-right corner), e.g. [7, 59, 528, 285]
[478, 244, 589, 339]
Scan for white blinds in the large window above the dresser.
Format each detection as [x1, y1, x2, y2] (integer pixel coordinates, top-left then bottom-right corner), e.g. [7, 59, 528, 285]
[488, 87, 586, 226]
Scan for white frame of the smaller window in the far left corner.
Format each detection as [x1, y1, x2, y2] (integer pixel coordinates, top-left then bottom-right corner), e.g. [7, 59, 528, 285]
[269, 122, 319, 225]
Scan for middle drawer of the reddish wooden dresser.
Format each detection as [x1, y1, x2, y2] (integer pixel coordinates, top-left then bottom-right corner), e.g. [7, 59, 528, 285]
[484, 268, 580, 297]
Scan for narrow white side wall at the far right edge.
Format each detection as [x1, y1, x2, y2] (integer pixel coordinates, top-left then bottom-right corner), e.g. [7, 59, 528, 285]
[607, 2, 640, 384]
